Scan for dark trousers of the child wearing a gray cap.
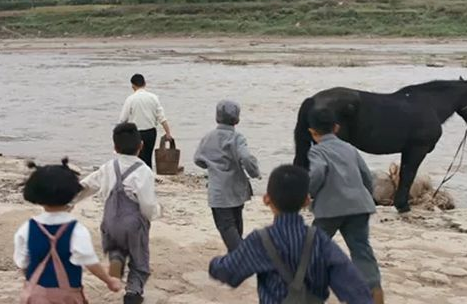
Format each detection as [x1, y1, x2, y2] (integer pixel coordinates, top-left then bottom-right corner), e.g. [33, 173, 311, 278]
[212, 205, 243, 252]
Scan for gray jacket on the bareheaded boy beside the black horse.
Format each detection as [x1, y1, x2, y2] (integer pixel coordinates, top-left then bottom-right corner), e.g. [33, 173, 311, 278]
[308, 134, 376, 218]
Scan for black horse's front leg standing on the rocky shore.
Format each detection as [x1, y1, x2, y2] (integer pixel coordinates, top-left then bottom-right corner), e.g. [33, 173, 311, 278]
[394, 146, 431, 213]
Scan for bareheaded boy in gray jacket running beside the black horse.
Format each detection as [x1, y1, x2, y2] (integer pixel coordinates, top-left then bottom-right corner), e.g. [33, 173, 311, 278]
[308, 109, 384, 304]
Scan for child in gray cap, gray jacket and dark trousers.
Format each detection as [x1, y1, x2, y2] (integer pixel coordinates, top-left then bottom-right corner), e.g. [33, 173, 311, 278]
[194, 101, 260, 252]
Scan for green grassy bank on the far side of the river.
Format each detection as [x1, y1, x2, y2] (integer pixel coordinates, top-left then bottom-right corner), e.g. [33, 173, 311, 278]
[0, 0, 467, 37]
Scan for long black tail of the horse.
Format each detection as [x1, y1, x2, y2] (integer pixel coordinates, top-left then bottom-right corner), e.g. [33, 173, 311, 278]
[293, 97, 315, 170]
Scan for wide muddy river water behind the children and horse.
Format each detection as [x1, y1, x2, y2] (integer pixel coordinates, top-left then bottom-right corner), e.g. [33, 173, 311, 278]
[0, 38, 467, 207]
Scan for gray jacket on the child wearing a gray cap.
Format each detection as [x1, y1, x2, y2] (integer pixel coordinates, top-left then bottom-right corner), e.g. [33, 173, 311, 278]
[194, 124, 260, 208]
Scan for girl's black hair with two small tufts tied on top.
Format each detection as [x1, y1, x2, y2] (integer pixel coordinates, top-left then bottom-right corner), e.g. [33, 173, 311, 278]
[23, 158, 83, 206]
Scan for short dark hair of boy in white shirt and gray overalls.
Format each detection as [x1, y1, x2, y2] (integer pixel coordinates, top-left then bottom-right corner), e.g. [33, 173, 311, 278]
[113, 122, 141, 155]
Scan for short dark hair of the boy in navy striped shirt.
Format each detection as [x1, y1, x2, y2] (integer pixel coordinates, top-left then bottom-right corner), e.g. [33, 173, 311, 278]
[267, 165, 310, 213]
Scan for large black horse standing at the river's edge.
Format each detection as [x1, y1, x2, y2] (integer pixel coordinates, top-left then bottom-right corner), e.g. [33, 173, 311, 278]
[294, 78, 467, 212]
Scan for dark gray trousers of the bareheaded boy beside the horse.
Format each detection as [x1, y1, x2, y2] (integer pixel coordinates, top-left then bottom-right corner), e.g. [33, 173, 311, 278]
[313, 214, 381, 289]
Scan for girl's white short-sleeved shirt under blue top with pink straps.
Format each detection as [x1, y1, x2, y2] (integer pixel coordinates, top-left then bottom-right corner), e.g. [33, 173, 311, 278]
[13, 212, 99, 269]
